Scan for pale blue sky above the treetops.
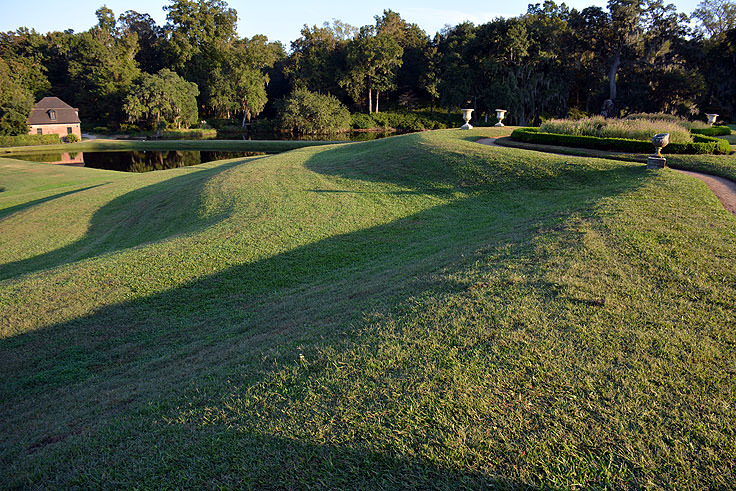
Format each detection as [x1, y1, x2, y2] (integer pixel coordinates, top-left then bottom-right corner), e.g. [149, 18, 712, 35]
[0, 0, 700, 49]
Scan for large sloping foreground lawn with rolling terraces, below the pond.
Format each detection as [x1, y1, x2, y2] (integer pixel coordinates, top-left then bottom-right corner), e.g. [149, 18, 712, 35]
[0, 128, 736, 489]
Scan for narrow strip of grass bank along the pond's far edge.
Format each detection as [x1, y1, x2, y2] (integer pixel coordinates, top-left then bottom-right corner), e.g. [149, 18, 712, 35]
[0, 136, 332, 156]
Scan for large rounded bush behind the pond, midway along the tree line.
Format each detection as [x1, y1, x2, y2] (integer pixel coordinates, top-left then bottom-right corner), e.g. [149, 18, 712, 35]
[278, 89, 350, 134]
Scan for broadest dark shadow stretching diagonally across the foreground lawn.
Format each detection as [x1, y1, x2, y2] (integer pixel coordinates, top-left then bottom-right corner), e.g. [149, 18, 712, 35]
[0, 142, 643, 488]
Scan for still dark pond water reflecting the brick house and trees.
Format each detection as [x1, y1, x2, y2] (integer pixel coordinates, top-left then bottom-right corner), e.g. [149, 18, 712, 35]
[11, 150, 265, 172]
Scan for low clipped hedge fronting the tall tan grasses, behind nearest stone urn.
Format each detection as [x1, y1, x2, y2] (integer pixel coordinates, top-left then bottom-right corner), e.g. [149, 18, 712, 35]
[511, 128, 731, 155]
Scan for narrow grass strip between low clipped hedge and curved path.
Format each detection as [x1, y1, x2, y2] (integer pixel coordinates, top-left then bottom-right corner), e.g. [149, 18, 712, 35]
[496, 138, 736, 181]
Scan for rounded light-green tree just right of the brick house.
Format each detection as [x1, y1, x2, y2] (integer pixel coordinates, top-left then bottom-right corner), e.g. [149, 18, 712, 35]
[123, 68, 199, 129]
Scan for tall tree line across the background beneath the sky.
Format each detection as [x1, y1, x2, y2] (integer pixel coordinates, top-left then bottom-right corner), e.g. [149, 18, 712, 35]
[0, 0, 736, 134]
